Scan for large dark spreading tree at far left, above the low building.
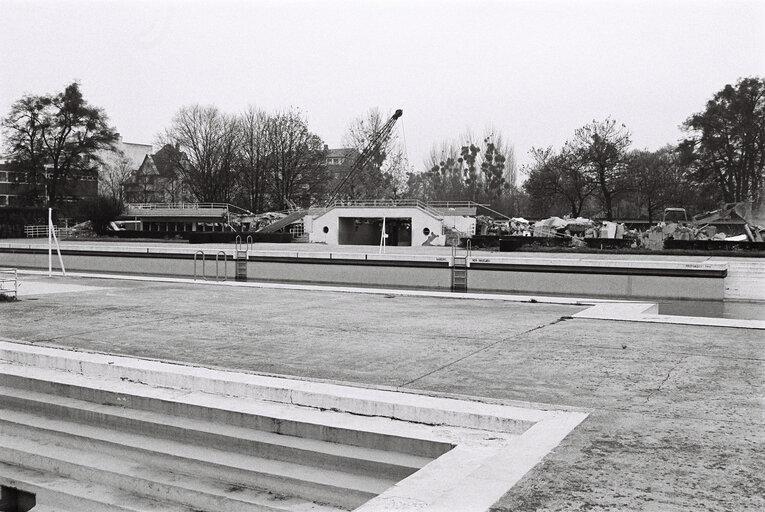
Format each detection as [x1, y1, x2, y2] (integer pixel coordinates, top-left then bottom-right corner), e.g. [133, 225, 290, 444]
[2, 82, 118, 206]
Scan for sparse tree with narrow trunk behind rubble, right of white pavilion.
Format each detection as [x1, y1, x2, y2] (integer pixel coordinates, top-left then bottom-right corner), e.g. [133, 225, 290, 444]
[565, 118, 632, 220]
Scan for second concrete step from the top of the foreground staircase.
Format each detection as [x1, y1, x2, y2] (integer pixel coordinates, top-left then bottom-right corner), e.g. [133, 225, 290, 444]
[0, 388, 432, 481]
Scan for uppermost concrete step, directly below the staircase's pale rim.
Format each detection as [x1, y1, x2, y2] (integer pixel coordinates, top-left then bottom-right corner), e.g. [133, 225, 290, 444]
[0, 373, 452, 458]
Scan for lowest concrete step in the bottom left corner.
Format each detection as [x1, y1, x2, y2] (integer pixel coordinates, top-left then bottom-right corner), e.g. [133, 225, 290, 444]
[0, 462, 194, 512]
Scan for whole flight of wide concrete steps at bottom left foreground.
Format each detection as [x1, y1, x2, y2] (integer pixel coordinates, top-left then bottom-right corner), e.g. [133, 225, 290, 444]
[0, 364, 442, 512]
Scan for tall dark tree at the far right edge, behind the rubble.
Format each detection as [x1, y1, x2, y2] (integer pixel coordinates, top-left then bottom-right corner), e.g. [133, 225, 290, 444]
[680, 77, 765, 206]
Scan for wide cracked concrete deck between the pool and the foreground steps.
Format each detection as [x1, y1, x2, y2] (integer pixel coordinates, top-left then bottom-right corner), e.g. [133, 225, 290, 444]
[0, 279, 765, 512]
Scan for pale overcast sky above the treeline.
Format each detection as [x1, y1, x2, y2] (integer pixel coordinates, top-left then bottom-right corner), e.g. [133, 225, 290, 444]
[0, 0, 765, 176]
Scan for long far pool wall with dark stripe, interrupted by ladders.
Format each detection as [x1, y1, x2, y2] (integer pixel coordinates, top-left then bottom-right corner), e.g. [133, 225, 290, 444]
[0, 246, 727, 300]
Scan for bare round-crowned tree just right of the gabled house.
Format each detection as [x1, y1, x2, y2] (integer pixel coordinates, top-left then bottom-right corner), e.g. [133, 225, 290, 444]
[160, 105, 239, 203]
